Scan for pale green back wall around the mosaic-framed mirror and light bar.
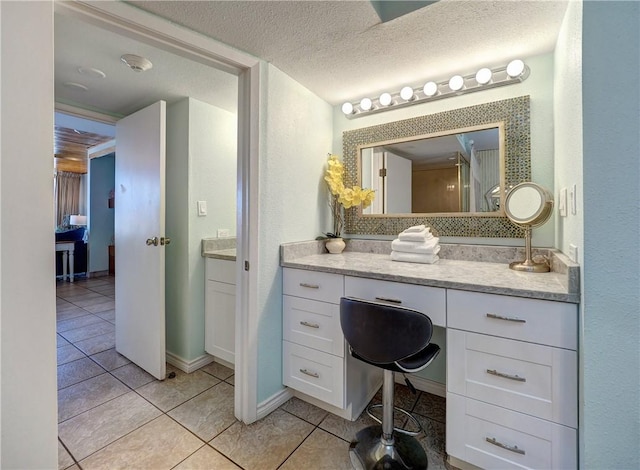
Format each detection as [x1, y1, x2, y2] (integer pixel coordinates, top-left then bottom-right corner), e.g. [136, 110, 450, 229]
[327, 54, 555, 246]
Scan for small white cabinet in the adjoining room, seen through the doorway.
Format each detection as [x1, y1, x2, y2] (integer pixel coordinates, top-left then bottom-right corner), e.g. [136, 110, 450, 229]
[204, 258, 236, 364]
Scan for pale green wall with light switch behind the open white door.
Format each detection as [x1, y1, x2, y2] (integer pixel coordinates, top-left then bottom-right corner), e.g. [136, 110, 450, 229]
[166, 98, 237, 361]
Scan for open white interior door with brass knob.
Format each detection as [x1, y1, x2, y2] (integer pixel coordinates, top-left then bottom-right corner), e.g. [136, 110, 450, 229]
[115, 101, 166, 380]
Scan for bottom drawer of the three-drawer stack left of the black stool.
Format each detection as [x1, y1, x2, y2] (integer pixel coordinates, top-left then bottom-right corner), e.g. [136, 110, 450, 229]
[282, 341, 344, 408]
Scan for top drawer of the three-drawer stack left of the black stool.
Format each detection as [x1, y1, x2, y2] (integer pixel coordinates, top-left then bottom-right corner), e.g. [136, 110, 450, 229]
[282, 268, 344, 304]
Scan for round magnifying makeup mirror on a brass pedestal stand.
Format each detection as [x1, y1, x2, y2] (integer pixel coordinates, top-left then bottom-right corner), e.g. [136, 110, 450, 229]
[504, 182, 553, 273]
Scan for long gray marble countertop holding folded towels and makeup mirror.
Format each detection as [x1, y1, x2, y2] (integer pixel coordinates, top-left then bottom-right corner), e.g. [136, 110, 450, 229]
[281, 242, 580, 303]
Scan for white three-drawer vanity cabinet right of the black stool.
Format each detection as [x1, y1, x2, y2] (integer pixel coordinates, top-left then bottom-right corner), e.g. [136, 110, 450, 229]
[447, 290, 578, 469]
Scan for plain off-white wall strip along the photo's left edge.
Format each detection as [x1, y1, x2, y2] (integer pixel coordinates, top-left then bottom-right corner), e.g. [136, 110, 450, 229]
[0, 2, 58, 469]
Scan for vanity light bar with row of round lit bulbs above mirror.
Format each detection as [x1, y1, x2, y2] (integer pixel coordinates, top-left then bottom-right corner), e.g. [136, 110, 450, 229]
[342, 59, 530, 119]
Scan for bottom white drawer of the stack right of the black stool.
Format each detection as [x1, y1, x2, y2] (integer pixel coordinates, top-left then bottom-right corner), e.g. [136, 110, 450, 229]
[447, 393, 578, 469]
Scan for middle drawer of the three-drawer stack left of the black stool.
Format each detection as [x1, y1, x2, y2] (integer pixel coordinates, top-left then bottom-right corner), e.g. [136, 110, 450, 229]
[282, 295, 344, 357]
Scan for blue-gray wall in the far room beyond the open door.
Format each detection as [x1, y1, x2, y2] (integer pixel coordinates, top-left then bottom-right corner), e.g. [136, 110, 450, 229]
[88, 154, 116, 273]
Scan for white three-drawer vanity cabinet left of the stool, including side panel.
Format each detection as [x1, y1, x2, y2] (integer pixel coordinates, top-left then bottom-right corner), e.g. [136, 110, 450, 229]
[282, 268, 382, 420]
